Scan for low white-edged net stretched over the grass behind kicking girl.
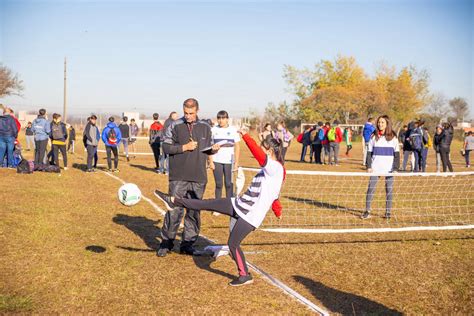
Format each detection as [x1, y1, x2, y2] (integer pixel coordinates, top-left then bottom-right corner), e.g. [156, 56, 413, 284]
[244, 168, 474, 233]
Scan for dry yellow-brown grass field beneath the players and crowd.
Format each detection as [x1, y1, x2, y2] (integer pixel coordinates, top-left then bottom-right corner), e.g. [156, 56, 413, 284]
[0, 135, 474, 315]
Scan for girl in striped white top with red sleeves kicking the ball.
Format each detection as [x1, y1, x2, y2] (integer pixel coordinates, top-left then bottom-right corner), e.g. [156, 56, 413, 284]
[155, 129, 286, 286]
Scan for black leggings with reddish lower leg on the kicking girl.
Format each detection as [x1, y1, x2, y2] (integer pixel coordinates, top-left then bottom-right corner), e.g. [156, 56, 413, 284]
[174, 198, 255, 276]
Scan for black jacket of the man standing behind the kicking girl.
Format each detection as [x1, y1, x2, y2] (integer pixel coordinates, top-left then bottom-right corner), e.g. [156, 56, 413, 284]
[163, 117, 212, 183]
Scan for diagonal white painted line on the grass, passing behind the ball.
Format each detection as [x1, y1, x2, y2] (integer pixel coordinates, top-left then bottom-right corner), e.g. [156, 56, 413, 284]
[101, 171, 329, 316]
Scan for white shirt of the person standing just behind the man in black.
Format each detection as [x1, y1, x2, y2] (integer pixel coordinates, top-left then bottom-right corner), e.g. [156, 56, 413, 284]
[211, 126, 240, 164]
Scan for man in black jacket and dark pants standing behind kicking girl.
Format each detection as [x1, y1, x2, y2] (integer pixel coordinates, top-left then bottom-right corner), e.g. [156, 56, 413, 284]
[157, 99, 212, 257]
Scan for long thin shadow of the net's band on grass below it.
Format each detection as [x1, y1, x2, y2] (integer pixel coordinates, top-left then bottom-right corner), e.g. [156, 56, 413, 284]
[242, 237, 474, 246]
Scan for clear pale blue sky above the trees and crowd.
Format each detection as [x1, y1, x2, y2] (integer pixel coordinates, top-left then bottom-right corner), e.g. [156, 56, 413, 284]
[0, 0, 474, 116]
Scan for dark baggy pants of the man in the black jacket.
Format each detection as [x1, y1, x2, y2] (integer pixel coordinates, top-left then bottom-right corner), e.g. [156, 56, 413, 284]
[160, 181, 206, 249]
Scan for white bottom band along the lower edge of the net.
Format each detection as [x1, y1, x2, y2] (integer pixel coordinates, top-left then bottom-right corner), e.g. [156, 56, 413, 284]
[262, 225, 474, 234]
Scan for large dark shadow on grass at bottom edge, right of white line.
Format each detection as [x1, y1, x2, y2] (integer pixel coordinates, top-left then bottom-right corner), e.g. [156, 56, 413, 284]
[293, 275, 402, 315]
